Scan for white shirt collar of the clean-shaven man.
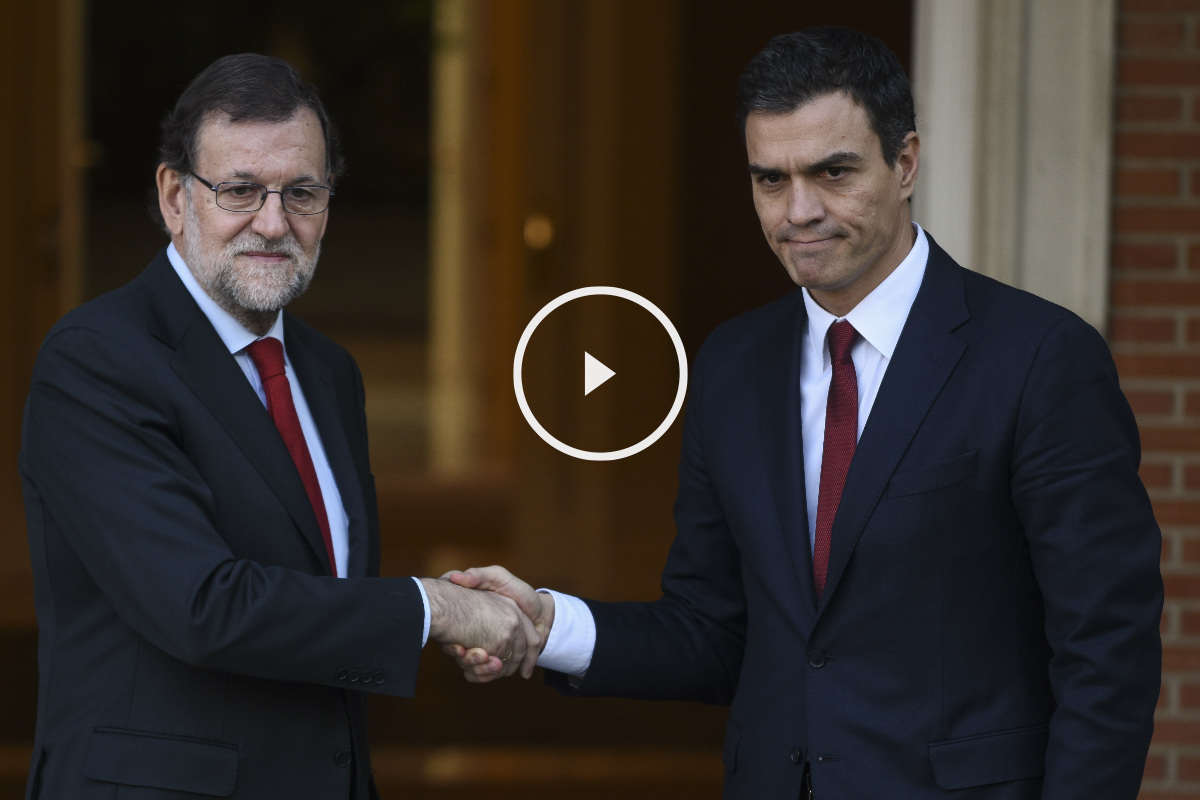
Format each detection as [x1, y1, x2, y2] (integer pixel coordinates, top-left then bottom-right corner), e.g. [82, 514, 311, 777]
[803, 222, 929, 363]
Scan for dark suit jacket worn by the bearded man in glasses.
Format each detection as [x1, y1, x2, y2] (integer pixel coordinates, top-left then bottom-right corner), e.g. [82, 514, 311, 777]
[20, 252, 424, 800]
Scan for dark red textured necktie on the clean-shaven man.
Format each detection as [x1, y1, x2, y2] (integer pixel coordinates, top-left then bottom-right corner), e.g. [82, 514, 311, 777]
[812, 320, 858, 597]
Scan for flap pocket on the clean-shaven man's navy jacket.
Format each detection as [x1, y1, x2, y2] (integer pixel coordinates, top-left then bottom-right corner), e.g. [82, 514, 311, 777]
[929, 726, 1050, 789]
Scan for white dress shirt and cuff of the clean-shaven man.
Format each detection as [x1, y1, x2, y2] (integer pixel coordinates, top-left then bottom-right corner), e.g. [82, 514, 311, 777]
[538, 222, 929, 676]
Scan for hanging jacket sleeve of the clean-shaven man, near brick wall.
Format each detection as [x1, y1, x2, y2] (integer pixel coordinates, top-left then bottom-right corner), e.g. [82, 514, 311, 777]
[1012, 317, 1163, 799]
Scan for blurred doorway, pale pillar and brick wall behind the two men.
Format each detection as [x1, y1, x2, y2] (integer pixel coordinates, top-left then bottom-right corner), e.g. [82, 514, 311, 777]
[0, 0, 1200, 800]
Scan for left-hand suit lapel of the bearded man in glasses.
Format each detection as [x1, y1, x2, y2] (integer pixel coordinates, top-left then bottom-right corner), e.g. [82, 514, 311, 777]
[145, 252, 340, 570]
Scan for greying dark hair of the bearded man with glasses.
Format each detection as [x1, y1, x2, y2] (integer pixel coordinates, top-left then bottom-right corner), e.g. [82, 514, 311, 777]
[158, 53, 344, 184]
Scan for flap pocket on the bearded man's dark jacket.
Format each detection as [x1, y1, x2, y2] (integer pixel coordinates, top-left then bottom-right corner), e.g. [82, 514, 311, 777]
[83, 727, 238, 798]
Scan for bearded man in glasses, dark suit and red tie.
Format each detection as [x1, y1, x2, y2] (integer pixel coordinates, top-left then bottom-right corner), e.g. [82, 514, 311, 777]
[20, 54, 540, 800]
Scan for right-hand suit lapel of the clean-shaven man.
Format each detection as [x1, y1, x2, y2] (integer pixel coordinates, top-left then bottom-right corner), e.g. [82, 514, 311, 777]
[817, 237, 970, 615]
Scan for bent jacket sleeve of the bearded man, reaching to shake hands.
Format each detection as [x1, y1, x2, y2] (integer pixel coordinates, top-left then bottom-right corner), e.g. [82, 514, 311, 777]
[20, 327, 424, 696]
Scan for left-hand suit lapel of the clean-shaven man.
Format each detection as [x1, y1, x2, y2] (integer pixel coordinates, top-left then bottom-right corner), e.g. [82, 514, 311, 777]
[758, 293, 816, 631]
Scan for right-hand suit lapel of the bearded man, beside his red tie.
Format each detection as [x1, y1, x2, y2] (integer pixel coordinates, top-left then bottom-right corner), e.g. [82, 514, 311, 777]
[283, 314, 367, 578]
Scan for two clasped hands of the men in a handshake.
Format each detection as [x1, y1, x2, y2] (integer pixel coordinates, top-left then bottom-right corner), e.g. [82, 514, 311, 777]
[421, 566, 554, 684]
